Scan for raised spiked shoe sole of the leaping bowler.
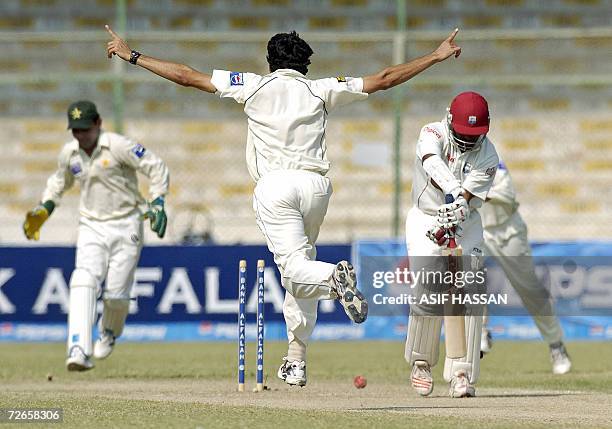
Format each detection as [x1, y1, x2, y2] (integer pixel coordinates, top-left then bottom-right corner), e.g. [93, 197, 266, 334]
[332, 261, 368, 323]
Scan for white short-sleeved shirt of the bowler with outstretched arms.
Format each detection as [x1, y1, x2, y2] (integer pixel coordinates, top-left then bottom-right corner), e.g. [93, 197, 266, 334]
[212, 69, 368, 181]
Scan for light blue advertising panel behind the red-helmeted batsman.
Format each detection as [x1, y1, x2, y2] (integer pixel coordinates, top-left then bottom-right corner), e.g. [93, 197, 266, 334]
[352, 239, 612, 340]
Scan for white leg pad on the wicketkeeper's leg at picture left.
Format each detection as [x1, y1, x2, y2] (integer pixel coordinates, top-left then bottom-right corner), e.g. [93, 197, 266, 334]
[68, 268, 98, 356]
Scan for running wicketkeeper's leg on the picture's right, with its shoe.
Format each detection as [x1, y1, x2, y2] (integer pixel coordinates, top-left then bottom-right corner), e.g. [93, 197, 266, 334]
[94, 215, 143, 359]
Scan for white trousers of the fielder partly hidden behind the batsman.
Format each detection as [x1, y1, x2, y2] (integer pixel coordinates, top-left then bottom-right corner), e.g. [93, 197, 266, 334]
[484, 222, 563, 344]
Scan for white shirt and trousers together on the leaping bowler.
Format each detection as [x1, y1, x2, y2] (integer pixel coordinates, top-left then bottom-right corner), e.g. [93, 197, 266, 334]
[212, 69, 368, 354]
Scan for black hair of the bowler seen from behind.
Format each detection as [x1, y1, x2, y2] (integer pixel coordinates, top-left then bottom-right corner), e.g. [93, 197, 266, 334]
[266, 31, 313, 74]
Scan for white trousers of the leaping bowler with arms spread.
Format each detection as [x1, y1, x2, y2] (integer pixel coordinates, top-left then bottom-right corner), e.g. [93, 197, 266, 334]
[253, 170, 335, 359]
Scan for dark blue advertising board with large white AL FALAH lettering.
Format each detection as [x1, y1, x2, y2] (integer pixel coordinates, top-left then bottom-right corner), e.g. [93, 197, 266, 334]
[0, 245, 351, 341]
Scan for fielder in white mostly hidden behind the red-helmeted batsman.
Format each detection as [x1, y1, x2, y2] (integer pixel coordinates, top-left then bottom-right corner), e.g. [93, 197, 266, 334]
[480, 155, 572, 374]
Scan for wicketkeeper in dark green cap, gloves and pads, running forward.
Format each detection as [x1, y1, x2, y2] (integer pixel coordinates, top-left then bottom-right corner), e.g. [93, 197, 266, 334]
[23, 101, 169, 371]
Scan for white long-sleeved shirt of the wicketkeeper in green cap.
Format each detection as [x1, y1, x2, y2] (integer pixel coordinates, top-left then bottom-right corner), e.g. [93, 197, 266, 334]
[42, 131, 169, 221]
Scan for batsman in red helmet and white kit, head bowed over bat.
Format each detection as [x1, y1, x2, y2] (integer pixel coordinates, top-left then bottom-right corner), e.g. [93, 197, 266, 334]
[405, 92, 499, 397]
